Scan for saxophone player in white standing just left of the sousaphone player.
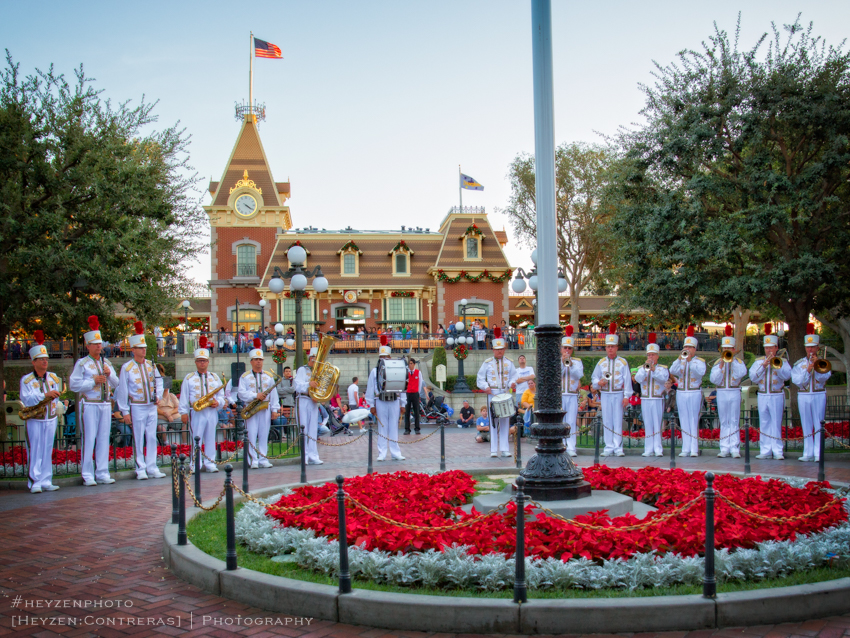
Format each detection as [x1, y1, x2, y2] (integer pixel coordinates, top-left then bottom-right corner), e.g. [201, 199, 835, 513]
[237, 338, 280, 470]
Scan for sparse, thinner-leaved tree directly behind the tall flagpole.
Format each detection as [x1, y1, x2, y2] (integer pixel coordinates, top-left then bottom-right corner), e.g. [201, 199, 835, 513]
[503, 143, 611, 329]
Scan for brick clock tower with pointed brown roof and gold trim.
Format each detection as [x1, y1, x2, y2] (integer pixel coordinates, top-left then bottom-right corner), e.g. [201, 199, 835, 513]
[204, 112, 292, 331]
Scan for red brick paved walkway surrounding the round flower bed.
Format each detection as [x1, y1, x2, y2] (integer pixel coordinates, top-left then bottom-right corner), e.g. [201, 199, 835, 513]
[0, 428, 850, 638]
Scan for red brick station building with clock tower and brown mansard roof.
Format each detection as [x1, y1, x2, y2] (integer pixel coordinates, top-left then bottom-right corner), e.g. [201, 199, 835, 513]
[204, 114, 511, 332]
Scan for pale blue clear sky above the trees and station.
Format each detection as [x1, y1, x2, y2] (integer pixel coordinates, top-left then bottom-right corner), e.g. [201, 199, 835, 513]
[0, 0, 850, 281]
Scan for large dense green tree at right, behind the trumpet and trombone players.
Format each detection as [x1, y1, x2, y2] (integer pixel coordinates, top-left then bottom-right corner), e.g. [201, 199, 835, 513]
[607, 20, 850, 368]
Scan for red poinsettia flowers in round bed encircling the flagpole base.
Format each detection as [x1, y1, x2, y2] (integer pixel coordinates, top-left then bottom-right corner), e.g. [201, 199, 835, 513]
[268, 466, 847, 560]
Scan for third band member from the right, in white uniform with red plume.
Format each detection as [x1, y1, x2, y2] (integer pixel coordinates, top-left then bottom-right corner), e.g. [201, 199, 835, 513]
[709, 325, 747, 459]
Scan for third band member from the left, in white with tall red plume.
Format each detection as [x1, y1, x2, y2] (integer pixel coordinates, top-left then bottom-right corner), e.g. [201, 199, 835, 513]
[115, 321, 165, 481]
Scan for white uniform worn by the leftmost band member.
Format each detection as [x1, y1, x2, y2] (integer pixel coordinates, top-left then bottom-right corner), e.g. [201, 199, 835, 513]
[19, 372, 61, 490]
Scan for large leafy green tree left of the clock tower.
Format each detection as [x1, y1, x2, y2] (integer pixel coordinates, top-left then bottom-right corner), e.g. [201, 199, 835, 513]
[0, 51, 206, 431]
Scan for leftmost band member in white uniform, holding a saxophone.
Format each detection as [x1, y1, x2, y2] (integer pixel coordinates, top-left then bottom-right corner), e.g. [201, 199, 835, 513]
[19, 330, 62, 494]
